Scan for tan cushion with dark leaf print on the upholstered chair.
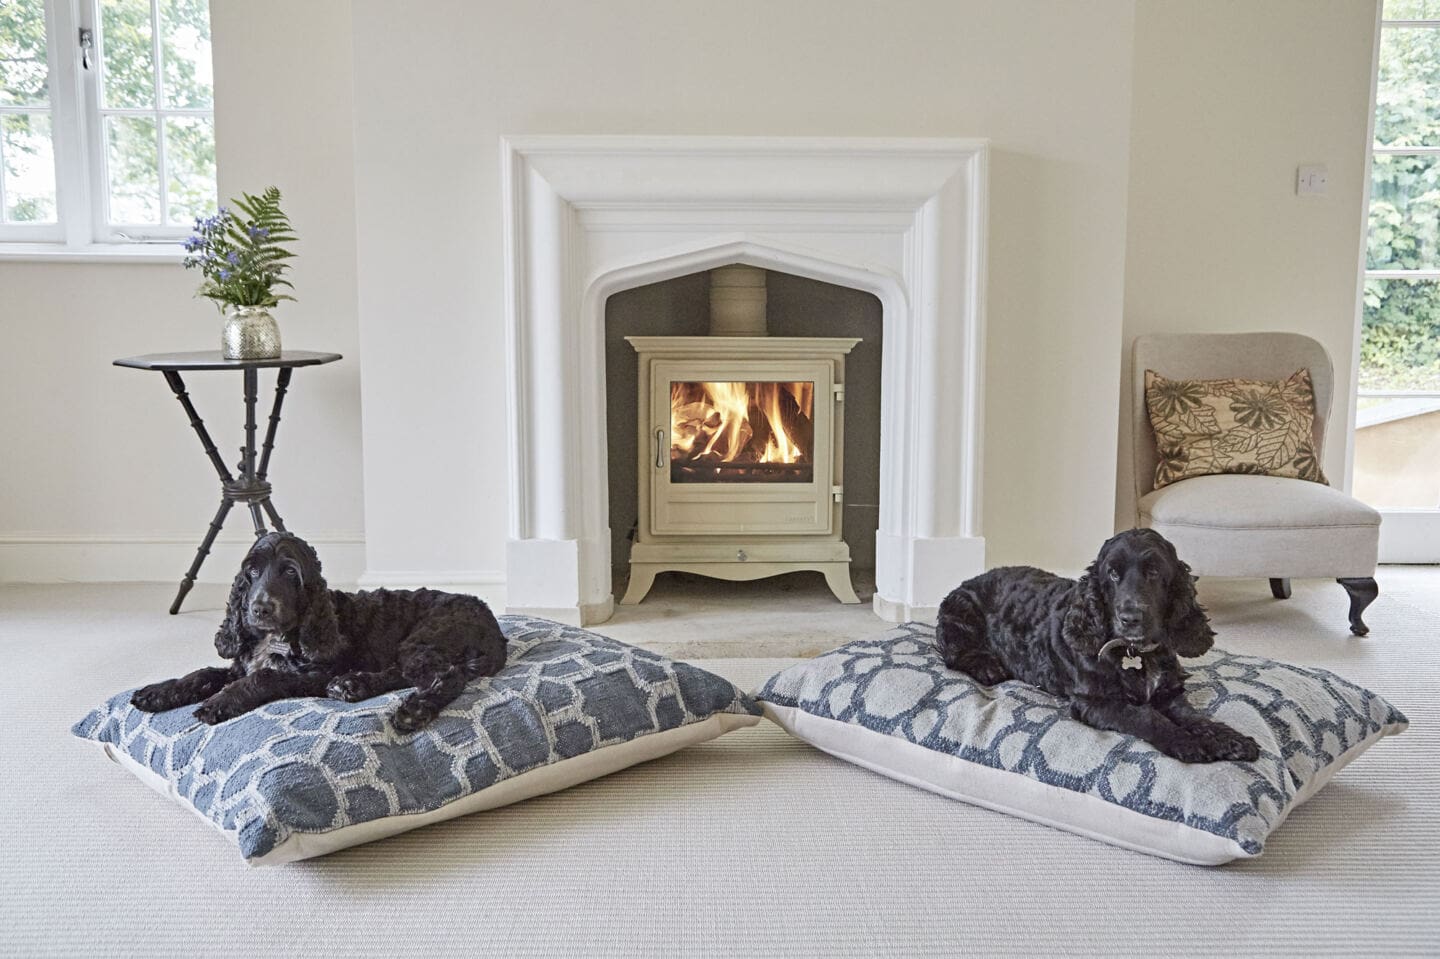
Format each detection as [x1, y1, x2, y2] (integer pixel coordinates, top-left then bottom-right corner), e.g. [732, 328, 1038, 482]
[1145, 370, 1326, 490]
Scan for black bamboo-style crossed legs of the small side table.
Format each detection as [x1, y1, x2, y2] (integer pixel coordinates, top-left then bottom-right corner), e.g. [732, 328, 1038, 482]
[164, 367, 291, 615]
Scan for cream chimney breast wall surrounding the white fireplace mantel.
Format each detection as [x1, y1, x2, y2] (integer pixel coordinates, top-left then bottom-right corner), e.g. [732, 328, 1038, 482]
[354, 0, 1132, 582]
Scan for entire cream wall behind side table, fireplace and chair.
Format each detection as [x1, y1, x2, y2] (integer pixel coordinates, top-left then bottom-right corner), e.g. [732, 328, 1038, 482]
[0, 0, 1374, 595]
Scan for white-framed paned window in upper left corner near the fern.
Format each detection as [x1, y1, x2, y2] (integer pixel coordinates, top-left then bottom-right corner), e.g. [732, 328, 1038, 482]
[0, 0, 216, 251]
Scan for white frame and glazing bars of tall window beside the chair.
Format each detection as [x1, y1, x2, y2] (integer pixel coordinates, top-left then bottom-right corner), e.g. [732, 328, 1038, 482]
[1351, 0, 1440, 563]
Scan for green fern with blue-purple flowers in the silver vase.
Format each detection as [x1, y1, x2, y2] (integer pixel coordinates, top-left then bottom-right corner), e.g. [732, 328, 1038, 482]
[184, 187, 300, 312]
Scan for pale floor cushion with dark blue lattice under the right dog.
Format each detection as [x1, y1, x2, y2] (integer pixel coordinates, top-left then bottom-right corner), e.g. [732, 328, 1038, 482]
[756, 623, 1405, 865]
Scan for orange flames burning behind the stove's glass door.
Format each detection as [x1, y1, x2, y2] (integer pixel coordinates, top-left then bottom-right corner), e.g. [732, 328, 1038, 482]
[670, 383, 815, 464]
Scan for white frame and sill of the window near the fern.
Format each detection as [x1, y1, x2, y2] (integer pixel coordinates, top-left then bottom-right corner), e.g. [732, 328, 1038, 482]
[0, 0, 215, 261]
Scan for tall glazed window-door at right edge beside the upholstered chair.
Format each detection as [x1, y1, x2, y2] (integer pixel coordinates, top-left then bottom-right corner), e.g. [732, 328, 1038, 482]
[1354, 0, 1440, 562]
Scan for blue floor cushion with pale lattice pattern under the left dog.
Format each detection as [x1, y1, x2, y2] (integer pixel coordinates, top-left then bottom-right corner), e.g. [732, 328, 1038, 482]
[73, 616, 760, 865]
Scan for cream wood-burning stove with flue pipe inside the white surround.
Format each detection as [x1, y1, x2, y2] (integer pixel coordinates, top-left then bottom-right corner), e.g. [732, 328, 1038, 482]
[621, 266, 860, 605]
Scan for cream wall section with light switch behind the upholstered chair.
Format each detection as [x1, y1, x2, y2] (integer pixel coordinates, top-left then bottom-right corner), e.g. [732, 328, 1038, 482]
[1116, 0, 1377, 528]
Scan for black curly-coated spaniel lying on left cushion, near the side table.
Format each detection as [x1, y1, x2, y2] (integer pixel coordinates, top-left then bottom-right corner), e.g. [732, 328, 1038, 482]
[130, 533, 505, 733]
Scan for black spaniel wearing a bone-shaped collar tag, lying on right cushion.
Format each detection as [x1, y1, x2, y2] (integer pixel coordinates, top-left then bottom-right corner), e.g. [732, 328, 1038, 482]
[936, 530, 1260, 763]
